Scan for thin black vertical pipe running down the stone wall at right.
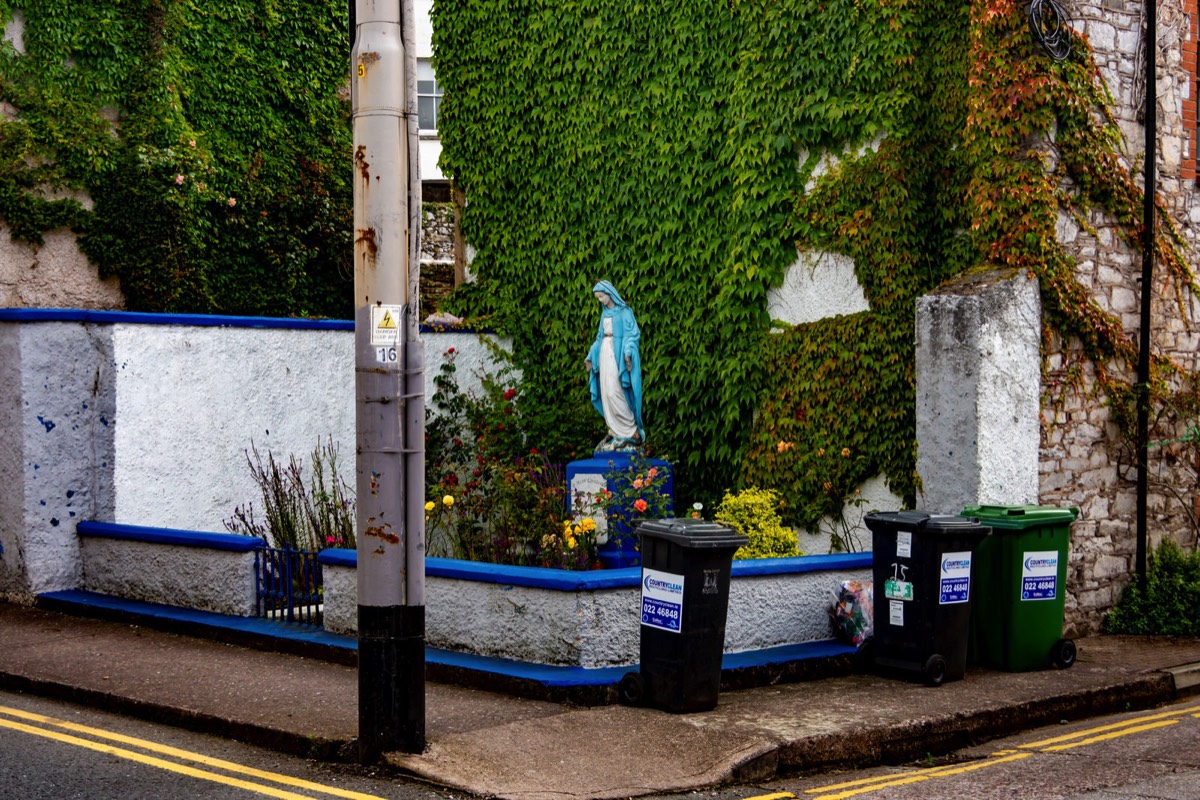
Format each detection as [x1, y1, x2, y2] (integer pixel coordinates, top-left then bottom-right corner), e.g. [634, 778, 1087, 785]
[1135, 0, 1158, 581]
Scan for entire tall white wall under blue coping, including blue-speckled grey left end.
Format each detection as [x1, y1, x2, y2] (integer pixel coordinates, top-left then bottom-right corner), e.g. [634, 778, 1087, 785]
[0, 312, 504, 600]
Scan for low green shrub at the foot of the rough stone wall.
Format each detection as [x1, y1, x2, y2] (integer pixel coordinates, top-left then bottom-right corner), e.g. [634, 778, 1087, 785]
[1104, 539, 1200, 636]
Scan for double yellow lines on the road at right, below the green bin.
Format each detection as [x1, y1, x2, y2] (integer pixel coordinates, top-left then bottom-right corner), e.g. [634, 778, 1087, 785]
[744, 705, 1200, 800]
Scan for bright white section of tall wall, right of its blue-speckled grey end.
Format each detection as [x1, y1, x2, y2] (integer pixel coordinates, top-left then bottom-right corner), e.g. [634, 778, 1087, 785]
[112, 325, 501, 531]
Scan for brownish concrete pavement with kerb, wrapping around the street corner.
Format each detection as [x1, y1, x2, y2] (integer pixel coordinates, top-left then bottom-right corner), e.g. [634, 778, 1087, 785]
[0, 603, 1200, 800]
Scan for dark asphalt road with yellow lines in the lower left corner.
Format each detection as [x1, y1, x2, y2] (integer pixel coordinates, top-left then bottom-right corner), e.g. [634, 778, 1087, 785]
[0, 692, 461, 800]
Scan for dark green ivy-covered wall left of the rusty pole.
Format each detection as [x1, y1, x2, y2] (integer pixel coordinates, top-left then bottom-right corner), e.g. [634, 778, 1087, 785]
[0, 0, 353, 318]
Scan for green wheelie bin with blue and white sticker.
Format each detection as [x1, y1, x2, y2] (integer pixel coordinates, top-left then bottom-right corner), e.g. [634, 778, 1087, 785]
[962, 505, 1079, 672]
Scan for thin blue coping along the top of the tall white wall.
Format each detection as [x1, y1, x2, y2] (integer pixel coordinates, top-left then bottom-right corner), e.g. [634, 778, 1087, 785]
[0, 308, 492, 333]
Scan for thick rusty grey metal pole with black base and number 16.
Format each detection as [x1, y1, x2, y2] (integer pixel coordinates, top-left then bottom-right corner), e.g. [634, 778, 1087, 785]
[350, 0, 425, 763]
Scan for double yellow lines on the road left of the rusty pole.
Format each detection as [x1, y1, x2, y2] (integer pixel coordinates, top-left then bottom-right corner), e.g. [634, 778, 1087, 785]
[0, 705, 383, 800]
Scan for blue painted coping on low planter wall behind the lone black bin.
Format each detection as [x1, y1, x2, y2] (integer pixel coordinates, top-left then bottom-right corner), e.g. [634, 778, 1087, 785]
[318, 549, 871, 591]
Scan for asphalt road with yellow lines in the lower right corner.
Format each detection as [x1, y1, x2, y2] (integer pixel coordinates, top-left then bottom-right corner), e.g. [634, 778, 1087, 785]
[688, 697, 1200, 800]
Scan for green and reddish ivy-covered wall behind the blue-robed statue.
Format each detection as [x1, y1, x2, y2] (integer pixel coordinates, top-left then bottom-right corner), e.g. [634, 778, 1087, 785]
[433, 0, 1196, 527]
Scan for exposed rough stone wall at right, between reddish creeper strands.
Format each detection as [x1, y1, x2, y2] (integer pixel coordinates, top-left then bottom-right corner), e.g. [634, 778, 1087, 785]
[1039, 0, 1200, 636]
